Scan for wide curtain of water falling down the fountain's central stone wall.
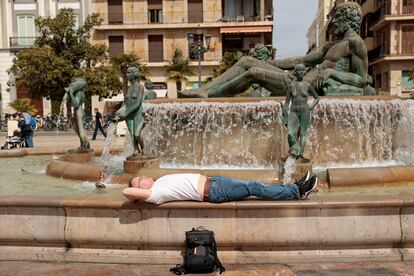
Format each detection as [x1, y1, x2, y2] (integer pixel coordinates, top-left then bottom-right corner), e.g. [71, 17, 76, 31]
[143, 98, 414, 169]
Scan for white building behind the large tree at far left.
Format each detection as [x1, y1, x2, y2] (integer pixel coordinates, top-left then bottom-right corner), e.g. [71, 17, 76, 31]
[0, 0, 89, 114]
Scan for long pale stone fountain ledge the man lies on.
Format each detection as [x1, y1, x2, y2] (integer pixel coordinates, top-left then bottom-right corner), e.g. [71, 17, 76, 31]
[0, 195, 414, 265]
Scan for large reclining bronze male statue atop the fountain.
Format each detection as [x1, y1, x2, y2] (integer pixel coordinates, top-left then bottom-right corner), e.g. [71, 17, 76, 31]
[180, 2, 374, 97]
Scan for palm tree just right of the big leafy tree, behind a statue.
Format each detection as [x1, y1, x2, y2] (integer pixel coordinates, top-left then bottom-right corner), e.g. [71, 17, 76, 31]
[111, 53, 149, 96]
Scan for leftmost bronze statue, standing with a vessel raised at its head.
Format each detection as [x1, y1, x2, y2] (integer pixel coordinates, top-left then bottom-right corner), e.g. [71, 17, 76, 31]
[65, 78, 91, 153]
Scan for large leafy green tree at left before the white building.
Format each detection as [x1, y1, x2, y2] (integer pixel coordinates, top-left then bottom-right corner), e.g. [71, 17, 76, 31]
[8, 9, 122, 114]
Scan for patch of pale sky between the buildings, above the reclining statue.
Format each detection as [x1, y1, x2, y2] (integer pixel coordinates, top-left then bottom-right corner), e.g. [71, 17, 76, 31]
[273, 0, 318, 59]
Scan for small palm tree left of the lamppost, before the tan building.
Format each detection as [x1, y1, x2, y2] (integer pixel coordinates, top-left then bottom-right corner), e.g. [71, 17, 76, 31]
[164, 49, 194, 90]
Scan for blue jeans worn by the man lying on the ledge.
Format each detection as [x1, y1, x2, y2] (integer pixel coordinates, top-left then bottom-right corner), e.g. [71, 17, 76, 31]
[209, 176, 299, 203]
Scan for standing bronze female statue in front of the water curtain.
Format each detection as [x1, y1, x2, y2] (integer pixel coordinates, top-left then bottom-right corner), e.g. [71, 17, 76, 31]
[283, 64, 319, 161]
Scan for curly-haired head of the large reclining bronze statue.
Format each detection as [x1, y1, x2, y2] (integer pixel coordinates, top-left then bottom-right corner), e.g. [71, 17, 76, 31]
[332, 2, 362, 36]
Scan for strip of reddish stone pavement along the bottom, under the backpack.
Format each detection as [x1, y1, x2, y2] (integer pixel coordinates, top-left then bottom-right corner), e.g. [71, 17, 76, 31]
[0, 261, 414, 276]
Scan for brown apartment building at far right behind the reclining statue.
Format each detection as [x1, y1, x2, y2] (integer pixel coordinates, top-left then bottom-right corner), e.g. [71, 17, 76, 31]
[358, 0, 414, 97]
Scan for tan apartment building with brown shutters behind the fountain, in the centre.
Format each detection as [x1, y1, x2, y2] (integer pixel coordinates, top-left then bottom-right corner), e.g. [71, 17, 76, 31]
[91, 0, 273, 98]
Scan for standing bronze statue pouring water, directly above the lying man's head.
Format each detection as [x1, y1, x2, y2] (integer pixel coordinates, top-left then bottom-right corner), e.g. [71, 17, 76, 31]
[114, 67, 144, 156]
